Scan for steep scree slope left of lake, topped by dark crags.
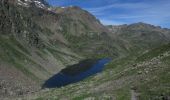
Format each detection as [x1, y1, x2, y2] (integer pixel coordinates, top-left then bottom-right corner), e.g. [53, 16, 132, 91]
[0, 1, 82, 96]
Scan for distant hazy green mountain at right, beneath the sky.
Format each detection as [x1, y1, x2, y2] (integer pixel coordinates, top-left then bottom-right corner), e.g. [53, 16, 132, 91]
[107, 22, 170, 54]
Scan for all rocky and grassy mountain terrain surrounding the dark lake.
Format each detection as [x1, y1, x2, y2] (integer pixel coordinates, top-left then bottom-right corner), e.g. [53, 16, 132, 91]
[0, 0, 170, 100]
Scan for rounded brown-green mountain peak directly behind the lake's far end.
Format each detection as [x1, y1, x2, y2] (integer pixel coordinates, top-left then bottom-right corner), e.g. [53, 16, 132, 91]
[30, 6, 119, 57]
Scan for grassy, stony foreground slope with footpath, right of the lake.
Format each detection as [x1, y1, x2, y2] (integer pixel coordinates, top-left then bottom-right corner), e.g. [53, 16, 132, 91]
[31, 44, 170, 100]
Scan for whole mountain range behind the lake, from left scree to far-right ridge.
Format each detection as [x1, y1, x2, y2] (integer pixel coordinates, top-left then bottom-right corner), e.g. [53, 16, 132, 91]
[0, 0, 170, 98]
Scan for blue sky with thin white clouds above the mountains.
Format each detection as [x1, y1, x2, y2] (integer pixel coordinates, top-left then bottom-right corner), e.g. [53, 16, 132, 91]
[47, 0, 170, 28]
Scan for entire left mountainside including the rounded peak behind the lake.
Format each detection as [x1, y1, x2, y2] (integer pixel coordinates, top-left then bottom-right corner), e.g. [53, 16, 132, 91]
[0, 0, 121, 97]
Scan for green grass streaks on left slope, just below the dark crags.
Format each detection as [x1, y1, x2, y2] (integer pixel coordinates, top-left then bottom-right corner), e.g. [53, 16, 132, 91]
[0, 37, 41, 80]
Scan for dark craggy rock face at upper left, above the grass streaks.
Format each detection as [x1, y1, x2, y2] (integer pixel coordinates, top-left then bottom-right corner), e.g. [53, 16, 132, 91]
[0, 2, 42, 47]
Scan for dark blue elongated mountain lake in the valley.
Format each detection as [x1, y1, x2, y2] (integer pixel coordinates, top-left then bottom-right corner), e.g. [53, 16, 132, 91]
[43, 58, 111, 88]
